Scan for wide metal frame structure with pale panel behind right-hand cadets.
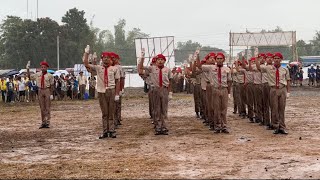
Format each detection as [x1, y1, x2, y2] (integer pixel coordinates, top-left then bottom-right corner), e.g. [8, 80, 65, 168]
[229, 31, 298, 61]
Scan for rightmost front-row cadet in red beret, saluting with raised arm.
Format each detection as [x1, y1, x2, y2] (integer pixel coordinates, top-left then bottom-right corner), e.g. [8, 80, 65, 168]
[256, 53, 290, 134]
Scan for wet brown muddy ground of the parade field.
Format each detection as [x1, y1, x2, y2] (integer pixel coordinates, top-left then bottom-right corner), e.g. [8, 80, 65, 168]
[0, 87, 320, 179]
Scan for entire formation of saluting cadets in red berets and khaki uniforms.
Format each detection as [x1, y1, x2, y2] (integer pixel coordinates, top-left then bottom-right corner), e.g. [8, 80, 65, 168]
[21, 45, 290, 139]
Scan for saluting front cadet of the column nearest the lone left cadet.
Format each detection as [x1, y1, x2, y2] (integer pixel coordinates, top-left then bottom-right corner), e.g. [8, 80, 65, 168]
[83, 46, 120, 139]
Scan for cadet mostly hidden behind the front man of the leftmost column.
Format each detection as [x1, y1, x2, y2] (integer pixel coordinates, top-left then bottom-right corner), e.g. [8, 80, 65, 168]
[111, 53, 125, 128]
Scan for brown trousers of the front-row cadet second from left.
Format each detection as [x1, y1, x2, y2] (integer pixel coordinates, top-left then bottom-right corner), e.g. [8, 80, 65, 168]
[98, 89, 115, 133]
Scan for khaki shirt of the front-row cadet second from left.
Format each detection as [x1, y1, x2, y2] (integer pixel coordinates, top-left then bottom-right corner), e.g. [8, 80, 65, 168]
[89, 64, 120, 93]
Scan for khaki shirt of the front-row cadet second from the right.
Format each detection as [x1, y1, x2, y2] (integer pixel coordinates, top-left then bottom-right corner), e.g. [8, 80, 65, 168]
[202, 65, 232, 88]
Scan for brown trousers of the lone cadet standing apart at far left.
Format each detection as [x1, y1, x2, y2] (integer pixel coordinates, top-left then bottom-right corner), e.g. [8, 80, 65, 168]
[38, 88, 51, 125]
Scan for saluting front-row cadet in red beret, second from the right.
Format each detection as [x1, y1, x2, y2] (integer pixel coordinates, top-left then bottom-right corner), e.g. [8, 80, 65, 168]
[201, 53, 231, 133]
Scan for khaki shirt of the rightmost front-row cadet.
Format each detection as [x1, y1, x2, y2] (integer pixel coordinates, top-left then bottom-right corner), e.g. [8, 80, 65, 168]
[261, 65, 291, 86]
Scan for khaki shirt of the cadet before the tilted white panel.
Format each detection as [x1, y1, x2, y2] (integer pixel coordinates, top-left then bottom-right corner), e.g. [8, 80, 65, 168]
[145, 66, 172, 87]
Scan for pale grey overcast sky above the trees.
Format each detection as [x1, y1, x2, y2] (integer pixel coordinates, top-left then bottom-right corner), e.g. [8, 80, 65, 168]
[0, 0, 320, 49]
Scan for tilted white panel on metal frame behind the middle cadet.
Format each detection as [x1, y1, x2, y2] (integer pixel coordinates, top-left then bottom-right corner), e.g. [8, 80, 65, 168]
[135, 36, 175, 68]
